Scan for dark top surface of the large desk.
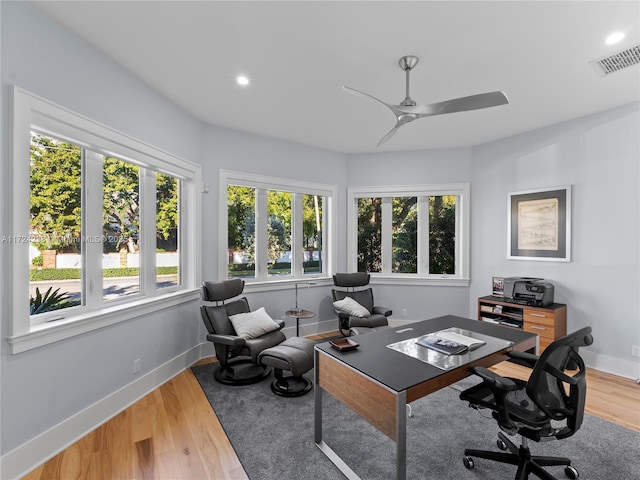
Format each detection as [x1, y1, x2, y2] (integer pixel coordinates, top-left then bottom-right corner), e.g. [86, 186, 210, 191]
[316, 315, 536, 392]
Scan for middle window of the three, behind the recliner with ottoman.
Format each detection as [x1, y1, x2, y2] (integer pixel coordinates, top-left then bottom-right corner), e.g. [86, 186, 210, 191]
[220, 170, 335, 282]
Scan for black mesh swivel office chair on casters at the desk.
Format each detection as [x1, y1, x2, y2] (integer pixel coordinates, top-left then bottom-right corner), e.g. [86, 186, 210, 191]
[460, 327, 593, 480]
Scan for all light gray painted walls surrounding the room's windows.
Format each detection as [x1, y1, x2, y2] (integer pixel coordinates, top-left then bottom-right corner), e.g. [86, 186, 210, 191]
[0, 2, 640, 478]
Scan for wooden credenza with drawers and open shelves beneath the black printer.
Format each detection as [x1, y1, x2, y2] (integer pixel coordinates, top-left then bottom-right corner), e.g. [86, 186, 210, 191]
[478, 295, 567, 353]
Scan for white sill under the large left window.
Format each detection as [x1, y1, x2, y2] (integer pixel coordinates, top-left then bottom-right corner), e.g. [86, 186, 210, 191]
[7, 289, 200, 354]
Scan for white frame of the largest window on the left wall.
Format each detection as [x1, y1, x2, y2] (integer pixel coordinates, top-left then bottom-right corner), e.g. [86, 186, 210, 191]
[2, 86, 202, 354]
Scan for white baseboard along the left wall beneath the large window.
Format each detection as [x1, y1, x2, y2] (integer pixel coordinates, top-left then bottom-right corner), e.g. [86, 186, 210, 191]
[0, 342, 215, 480]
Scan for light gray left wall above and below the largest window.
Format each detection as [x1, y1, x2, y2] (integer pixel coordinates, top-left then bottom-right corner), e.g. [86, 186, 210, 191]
[0, 2, 203, 472]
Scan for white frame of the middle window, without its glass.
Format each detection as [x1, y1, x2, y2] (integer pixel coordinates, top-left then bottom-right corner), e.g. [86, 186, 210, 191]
[218, 169, 337, 287]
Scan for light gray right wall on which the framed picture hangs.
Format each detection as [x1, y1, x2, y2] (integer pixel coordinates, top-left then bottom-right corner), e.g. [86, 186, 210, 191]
[469, 104, 640, 378]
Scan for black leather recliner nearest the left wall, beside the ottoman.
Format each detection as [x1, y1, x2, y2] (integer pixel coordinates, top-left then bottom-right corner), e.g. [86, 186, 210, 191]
[200, 278, 286, 385]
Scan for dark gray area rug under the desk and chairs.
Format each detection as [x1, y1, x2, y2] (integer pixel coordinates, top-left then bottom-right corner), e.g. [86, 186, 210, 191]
[193, 364, 640, 480]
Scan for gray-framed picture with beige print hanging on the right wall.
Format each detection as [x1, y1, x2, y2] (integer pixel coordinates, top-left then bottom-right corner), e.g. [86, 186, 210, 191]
[507, 185, 571, 262]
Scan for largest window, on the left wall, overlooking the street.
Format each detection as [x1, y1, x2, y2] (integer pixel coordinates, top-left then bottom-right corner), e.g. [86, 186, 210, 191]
[2, 87, 200, 353]
